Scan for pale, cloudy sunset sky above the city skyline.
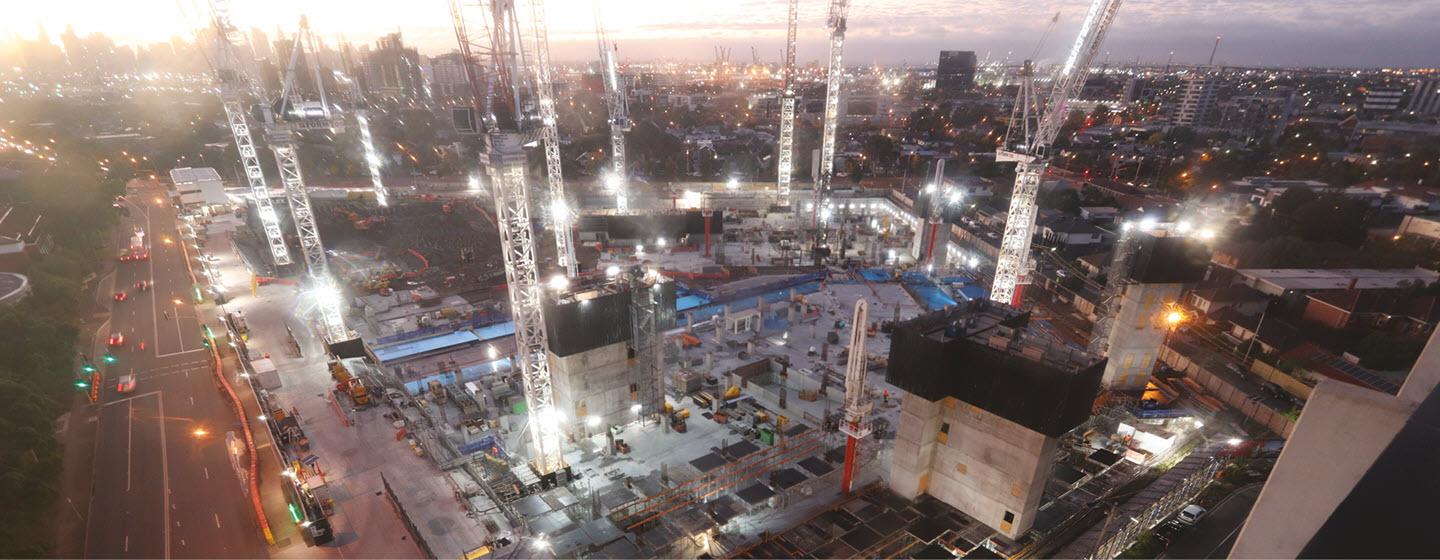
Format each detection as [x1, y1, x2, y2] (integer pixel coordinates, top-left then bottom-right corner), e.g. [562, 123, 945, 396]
[0, 0, 1440, 68]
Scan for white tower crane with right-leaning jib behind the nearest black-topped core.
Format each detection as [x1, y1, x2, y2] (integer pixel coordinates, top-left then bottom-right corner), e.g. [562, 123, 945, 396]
[991, 0, 1122, 305]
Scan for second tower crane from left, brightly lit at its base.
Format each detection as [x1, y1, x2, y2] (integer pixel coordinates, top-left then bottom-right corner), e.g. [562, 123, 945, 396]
[265, 16, 350, 341]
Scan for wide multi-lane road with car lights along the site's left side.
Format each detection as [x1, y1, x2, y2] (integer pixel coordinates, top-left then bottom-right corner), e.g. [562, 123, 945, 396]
[84, 183, 268, 559]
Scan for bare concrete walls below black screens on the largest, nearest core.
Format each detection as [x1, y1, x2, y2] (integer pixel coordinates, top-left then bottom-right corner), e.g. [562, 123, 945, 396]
[890, 393, 1058, 538]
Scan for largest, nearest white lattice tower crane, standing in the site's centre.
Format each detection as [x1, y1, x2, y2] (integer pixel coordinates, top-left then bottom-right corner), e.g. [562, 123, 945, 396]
[451, 0, 566, 481]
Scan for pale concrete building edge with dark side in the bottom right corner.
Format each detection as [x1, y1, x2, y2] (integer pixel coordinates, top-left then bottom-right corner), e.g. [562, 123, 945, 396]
[1230, 325, 1440, 559]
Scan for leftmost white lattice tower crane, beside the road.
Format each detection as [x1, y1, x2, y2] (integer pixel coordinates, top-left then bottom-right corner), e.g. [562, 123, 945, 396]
[210, 0, 292, 266]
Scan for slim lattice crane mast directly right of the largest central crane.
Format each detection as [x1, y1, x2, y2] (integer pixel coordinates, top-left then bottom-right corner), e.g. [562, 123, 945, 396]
[530, 0, 579, 278]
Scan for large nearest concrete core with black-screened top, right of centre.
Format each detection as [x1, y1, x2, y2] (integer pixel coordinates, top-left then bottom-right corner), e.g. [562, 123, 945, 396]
[886, 299, 1104, 538]
